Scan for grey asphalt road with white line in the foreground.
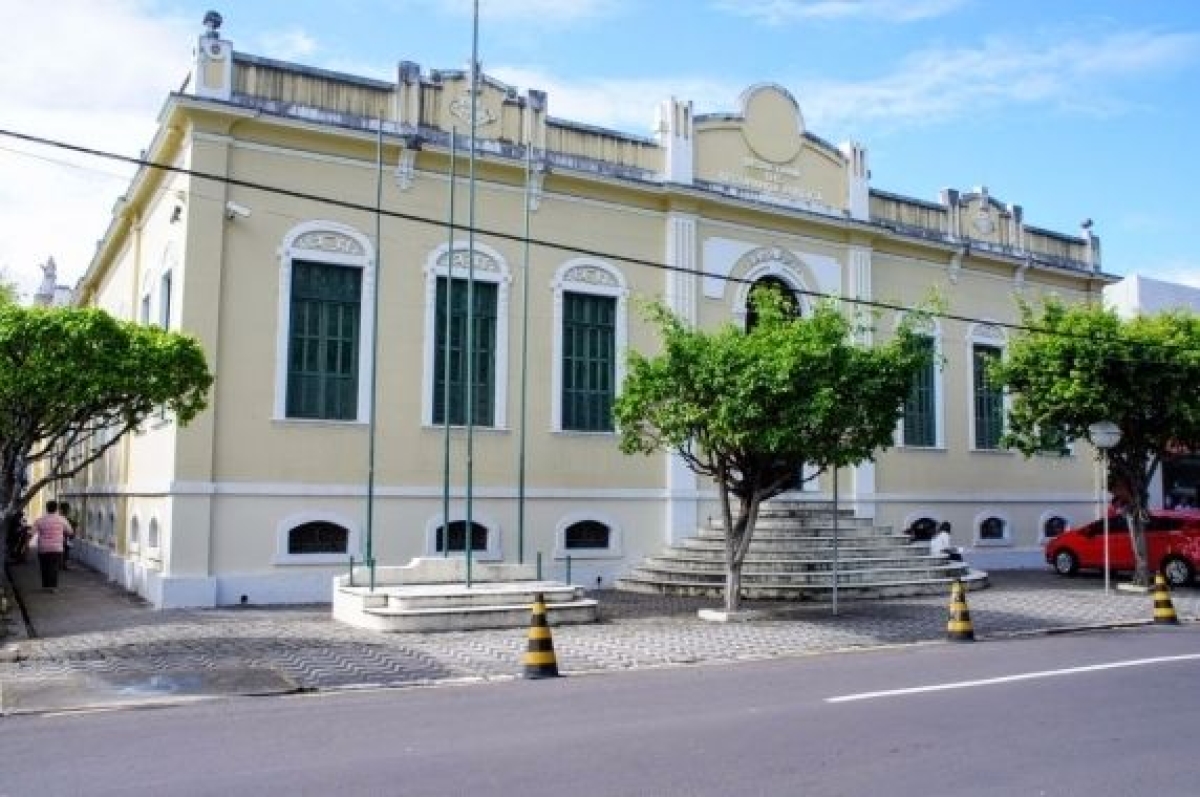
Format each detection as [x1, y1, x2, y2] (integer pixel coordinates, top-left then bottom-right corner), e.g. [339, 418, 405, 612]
[0, 625, 1200, 797]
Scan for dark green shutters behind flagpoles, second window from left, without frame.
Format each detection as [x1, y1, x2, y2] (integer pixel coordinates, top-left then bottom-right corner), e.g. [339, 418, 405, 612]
[433, 277, 497, 426]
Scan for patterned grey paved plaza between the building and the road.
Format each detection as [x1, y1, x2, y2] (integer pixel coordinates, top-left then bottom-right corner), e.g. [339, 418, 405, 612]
[0, 563, 1200, 713]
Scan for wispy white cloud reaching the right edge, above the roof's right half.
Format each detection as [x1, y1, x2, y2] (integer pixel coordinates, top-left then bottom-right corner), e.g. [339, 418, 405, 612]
[800, 30, 1200, 130]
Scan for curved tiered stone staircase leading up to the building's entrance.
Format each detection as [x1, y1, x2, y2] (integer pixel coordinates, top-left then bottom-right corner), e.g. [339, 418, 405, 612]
[616, 501, 988, 601]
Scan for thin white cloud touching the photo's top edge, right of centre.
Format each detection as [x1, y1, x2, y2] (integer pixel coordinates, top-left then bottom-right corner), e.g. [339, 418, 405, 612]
[713, 0, 967, 25]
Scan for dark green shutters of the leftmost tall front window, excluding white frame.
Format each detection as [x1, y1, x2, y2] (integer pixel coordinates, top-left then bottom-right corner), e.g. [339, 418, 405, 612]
[287, 260, 362, 420]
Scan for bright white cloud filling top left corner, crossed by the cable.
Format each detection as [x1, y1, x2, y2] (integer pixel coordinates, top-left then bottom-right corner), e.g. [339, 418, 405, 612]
[0, 0, 192, 300]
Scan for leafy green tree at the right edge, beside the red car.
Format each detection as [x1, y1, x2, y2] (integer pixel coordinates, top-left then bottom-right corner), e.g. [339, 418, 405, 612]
[990, 299, 1200, 585]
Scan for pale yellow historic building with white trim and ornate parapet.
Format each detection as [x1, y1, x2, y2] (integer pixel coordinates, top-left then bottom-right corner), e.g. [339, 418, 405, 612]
[64, 20, 1111, 606]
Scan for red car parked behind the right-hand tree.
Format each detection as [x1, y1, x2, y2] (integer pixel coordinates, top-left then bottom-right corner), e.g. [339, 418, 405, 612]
[1045, 509, 1200, 587]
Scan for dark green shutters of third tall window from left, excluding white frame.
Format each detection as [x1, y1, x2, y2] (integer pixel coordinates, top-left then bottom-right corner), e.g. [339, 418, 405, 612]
[562, 292, 617, 432]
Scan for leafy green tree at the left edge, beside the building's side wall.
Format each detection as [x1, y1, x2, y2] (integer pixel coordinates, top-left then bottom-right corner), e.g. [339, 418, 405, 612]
[0, 304, 212, 554]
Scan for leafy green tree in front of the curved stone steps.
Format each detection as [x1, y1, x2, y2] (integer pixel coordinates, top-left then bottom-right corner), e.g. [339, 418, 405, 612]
[613, 290, 932, 612]
